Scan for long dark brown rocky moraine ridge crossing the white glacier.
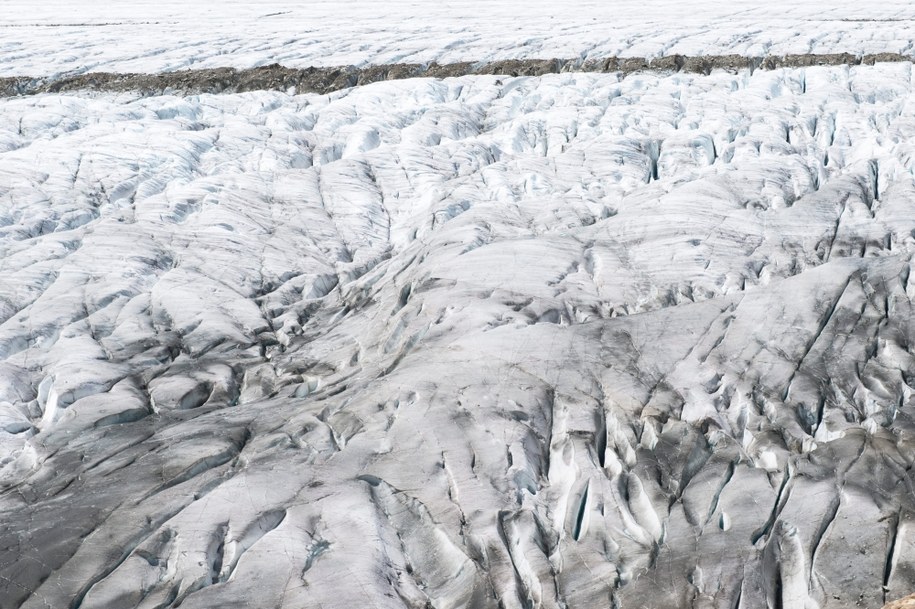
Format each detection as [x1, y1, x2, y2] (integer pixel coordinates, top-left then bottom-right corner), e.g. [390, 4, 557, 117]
[0, 53, 915, 97]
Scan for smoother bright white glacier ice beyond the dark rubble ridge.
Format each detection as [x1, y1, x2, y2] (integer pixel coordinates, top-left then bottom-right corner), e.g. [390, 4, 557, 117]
[0, 0, 915, 76]
